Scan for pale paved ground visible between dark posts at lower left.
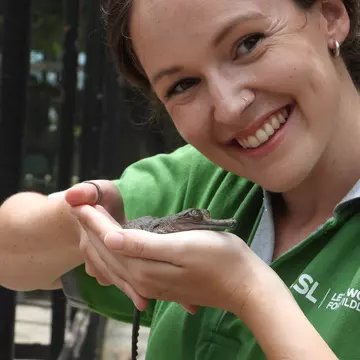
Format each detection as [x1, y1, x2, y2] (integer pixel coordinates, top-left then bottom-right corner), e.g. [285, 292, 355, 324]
[15, 303, 149, 360]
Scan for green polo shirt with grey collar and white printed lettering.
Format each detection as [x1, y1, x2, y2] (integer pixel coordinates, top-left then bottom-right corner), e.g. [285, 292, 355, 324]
[63, 145, 360, 360]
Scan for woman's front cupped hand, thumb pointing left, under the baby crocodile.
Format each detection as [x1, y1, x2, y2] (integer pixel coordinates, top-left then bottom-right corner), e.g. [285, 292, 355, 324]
[104, 230, 260, 312]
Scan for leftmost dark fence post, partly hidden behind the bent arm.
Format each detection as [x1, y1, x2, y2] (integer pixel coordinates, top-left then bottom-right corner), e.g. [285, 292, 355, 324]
[0, 0, 31, 360]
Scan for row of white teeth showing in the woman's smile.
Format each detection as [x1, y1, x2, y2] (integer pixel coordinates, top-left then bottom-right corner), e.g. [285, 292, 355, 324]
[236, 108, 289, 149]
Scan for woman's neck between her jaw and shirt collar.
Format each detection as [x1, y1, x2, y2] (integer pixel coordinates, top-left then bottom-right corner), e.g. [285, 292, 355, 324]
[274, 84, 360, 227]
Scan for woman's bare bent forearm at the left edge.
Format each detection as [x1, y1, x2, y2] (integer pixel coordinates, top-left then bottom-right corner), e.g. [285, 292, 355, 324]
[0, 193, 82, 290]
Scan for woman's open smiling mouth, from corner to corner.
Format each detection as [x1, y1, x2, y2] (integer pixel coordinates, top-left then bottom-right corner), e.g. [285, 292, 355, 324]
[233, 104, 294, 149]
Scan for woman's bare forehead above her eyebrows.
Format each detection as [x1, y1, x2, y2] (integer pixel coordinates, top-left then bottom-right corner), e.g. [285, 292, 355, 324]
[130, 0, 278, 71]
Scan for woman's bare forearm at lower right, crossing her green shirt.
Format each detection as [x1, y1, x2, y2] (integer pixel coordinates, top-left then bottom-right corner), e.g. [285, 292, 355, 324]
[240, 286, 337, 360]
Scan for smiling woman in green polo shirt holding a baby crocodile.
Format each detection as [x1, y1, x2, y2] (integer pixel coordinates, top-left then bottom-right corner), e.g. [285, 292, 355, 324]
[0, 0, 360, 360]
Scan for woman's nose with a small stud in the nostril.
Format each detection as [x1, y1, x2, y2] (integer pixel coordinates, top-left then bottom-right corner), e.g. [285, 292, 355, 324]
[210, 78, 255, 125]
